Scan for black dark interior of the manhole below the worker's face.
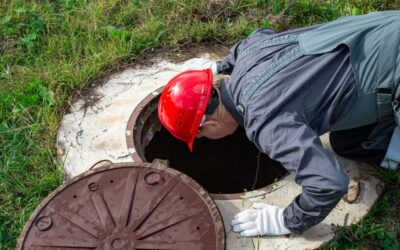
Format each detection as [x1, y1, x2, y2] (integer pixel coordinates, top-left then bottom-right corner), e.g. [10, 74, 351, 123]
[144, 127, 286, 194]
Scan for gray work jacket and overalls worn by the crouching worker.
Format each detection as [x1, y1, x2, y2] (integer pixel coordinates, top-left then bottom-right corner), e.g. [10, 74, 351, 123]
[218, 11, 400, 233]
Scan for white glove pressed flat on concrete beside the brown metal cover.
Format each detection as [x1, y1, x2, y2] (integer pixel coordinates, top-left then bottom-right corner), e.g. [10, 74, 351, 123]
[231, 203, 290, 236]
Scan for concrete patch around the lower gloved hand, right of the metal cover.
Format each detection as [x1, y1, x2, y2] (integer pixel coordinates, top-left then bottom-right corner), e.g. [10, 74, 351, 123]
[216, 135, 382, 250]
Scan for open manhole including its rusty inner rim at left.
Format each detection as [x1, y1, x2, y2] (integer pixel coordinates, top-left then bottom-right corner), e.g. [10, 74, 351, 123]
[127, 88, 287, 194]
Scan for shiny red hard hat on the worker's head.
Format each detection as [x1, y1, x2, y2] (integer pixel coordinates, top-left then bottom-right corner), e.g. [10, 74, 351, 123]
[158, 69, 213, 151]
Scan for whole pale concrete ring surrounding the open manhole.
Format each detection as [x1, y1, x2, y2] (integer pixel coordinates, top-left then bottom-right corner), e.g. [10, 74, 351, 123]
[56, 55, 381, 250]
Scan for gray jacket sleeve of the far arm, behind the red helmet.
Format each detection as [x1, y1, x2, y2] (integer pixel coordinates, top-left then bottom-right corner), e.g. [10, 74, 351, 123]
[217, 29, 276, 75]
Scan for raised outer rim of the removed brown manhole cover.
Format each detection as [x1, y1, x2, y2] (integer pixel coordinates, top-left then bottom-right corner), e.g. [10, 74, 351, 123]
[16, 160, 226, 249]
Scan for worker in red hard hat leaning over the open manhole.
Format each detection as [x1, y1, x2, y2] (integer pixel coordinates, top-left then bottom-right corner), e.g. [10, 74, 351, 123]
[158, 11, 400, 236]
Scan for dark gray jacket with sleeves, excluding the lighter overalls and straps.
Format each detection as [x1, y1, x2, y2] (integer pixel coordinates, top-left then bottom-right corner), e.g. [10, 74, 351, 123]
[217, 27, 358, 234]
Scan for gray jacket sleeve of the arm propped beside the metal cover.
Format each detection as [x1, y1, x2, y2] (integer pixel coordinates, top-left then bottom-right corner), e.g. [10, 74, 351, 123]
[246, 113, 348, 234]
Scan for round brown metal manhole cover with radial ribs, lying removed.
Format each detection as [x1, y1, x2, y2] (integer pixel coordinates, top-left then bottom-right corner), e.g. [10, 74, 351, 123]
[18, 161, 225, 250]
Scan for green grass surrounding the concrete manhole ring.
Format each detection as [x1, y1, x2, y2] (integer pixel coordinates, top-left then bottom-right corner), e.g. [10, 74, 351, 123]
[0, 0, 400, 249]
